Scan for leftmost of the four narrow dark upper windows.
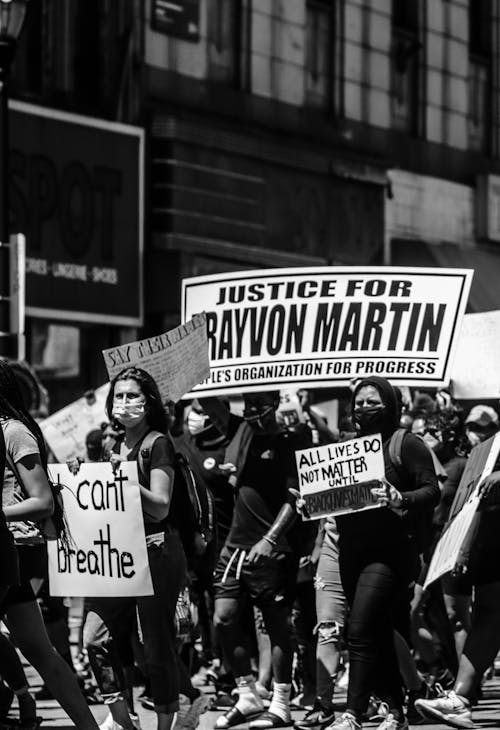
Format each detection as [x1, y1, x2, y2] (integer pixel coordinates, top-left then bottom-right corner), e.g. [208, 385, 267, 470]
[207, 0, 242, 86]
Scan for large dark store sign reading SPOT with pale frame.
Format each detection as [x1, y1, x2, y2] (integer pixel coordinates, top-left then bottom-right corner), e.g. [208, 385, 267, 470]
[9, 102, 144, 326]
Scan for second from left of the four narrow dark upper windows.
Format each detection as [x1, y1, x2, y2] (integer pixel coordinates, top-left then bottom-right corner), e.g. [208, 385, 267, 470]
[306, 0, 333, 108]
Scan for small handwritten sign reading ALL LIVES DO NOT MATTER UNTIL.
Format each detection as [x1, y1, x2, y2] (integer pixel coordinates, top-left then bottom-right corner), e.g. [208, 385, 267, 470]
[295, 434, 385, 519]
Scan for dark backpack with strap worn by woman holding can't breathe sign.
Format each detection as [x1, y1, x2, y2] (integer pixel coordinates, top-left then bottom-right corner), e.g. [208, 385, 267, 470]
[137, 431, 214, 561]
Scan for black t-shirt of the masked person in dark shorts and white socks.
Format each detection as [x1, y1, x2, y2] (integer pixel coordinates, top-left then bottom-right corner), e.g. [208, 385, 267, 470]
[227, 424, 311, 551]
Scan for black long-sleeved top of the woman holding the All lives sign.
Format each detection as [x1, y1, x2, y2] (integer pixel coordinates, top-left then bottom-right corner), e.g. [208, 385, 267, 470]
[336, 433, 440, 547]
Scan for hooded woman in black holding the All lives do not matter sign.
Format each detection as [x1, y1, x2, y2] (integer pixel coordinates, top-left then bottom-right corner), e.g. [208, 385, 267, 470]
[331, 377, 439, 730]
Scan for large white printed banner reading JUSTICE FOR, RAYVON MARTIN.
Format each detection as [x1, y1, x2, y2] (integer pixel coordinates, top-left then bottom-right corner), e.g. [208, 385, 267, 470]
[182, 267, 472, 395]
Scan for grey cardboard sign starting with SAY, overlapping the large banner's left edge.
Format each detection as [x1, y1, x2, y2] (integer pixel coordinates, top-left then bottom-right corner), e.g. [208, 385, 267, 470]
[102, 307, 210, 402]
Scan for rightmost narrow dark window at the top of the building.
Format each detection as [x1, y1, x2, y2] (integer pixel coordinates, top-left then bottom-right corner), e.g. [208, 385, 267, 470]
[468, 0, 493, 153]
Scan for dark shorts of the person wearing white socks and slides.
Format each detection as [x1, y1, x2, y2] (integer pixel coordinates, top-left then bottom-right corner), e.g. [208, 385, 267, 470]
[214, 545, 298, 608]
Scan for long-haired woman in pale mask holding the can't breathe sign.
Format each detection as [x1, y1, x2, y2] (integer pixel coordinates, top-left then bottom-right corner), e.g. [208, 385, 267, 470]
[84, 367, 186, 730]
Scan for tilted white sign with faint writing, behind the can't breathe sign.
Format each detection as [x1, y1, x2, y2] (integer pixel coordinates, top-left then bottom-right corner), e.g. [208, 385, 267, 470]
[40, 384, 109, 462]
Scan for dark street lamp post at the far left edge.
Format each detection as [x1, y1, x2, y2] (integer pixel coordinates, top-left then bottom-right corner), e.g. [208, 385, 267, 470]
[0, 0, 28, 357]
